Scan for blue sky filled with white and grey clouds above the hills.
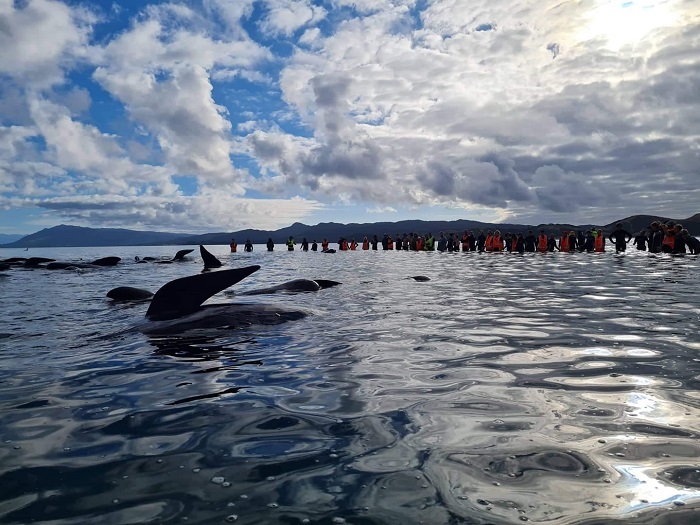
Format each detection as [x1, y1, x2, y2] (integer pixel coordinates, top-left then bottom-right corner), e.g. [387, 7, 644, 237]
[0, 0, 700, 234]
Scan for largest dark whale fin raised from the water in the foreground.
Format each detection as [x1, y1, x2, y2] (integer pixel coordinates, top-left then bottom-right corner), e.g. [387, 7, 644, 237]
[146, 265, 260, 321]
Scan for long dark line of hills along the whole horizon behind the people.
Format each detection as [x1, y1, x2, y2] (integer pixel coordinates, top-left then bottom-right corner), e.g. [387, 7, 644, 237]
[0, 213, 700, 248]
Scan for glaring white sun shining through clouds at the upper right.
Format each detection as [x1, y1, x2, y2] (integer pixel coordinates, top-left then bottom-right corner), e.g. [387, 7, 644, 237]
[580, 0, 678, 51]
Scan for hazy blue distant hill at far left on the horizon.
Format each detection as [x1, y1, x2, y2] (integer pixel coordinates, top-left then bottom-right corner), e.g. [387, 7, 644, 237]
[2, 224, 189, 248]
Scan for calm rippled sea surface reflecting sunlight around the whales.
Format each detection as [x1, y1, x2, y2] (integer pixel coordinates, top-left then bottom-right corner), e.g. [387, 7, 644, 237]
[0, 245, 700, 525]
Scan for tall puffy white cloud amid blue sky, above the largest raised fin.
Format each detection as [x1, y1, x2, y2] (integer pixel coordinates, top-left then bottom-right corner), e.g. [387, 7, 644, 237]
[93, 4, 268, 182]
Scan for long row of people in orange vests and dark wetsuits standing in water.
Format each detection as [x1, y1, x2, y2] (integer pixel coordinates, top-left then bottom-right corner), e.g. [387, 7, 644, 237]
[230, 221, 700, 254]
